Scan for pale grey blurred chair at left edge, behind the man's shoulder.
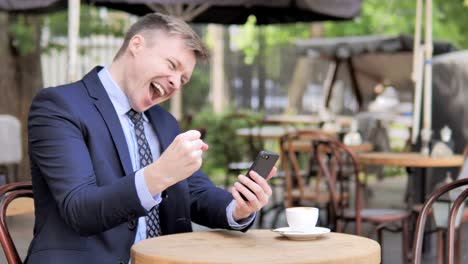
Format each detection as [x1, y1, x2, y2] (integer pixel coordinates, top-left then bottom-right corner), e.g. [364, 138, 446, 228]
[0, 115, 23, 182]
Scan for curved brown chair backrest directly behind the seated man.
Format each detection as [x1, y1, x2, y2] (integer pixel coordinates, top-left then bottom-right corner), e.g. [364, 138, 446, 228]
[0, 182, 33, 264]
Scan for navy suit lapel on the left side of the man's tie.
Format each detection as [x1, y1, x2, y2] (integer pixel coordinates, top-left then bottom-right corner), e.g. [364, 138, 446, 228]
[83, 67, 133, 175]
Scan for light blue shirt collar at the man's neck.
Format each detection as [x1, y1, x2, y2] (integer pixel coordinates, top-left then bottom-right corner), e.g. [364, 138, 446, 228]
[98, 66, 148, 122]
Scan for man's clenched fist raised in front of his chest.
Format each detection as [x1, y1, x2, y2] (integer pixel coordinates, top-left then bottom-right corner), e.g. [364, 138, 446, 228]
[144, 130, 208, 195]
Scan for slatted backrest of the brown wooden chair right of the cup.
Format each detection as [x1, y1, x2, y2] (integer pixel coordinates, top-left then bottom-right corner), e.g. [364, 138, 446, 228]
[315, 140, 362, 235]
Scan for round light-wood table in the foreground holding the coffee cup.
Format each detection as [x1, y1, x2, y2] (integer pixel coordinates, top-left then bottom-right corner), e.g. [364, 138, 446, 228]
[131, 230, 380, 264]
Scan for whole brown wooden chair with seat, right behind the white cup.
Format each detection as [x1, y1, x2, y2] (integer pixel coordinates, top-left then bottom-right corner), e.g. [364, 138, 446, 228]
[316, 140, 411, 263]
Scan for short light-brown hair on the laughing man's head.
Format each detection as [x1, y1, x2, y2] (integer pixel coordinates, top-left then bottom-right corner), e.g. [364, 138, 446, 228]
[114, 13, 209, 61]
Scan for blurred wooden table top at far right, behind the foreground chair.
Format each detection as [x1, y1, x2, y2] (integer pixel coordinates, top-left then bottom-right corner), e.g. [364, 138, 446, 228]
[358, 152, 464, 168]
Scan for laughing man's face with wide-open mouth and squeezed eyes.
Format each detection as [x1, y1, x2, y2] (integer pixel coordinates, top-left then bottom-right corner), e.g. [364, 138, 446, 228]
[122, 31, 196, 112]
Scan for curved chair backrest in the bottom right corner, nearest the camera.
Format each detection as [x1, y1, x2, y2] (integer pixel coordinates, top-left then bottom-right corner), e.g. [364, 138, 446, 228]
[413, 178, 468, 264]
